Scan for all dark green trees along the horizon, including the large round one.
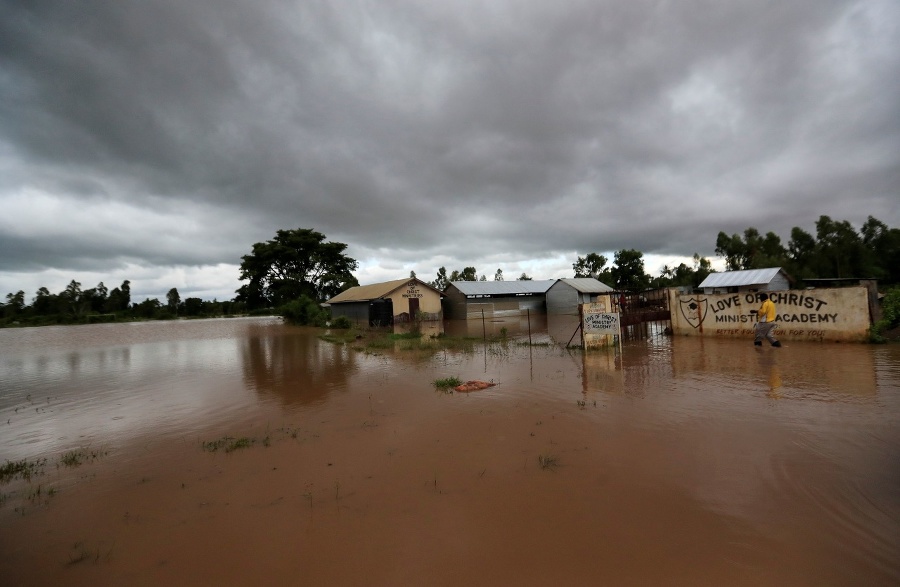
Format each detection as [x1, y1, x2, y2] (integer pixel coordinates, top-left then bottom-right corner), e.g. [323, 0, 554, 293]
[0, 216, 900, 326]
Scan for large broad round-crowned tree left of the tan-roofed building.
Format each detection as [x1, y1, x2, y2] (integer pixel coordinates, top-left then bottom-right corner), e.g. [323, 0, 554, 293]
[237, 228, 359, 309]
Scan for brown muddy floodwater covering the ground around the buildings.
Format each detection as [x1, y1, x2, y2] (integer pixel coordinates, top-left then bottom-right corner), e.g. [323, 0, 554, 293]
[0, 318, 900, 586]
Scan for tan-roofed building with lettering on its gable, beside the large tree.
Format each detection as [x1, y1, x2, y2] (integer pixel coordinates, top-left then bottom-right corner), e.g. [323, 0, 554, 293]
[326, 277, 443, 326]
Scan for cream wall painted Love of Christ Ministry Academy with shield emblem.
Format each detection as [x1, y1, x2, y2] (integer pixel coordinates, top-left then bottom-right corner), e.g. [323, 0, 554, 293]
[669, 287, 870, 342]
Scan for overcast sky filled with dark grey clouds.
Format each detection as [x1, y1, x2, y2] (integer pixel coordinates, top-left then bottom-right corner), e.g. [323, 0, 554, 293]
[0, 0, 900, 303]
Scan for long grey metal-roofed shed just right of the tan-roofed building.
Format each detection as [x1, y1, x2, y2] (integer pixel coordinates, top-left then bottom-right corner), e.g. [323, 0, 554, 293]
[444, 279, 556, 320]
